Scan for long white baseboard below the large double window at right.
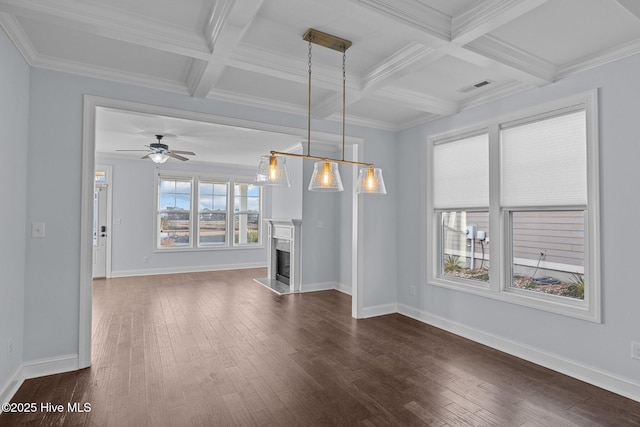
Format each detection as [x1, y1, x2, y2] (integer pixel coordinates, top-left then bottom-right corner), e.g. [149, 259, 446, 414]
[398, 304, 640, 402]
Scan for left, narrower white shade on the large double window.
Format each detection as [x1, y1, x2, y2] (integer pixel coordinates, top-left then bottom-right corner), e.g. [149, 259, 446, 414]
[433, 134, 489, 209]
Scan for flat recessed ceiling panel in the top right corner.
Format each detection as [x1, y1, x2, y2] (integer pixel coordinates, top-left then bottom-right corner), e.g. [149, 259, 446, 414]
[491, 0, 640, 66]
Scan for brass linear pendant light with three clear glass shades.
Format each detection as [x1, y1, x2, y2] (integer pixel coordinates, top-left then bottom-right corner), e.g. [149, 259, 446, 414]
[256, 28, 387, 194]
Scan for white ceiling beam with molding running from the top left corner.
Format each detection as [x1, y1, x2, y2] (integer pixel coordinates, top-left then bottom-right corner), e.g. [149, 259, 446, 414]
[0, 0, 211, 59]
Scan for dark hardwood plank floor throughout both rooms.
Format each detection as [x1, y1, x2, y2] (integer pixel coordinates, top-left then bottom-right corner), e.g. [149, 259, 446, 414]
[0, 269, 640, 427]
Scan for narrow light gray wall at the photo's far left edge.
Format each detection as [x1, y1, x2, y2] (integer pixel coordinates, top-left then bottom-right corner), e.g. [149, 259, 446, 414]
[0, 29, 30, 392]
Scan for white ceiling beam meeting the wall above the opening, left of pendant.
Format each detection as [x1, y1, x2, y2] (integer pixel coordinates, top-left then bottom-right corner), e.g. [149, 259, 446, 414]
[187, 0, 264, 98]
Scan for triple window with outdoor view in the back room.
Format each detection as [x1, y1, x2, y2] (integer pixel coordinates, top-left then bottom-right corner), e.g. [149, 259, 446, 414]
[156, 175, 262, 250]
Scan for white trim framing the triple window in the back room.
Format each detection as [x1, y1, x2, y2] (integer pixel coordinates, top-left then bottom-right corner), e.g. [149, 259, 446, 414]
[152, 170, 265, 253]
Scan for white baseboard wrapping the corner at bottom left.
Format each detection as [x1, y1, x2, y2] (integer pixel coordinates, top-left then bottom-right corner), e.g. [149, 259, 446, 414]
[0, 354, 78, 413]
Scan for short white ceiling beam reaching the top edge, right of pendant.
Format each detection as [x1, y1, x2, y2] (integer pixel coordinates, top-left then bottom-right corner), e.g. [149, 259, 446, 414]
[451, 0, 548, 45]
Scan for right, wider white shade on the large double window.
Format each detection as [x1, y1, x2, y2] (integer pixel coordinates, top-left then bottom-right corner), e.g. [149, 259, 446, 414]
[501, 110, 587, 207]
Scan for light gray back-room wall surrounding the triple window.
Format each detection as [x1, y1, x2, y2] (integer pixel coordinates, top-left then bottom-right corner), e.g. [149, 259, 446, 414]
[96, 157, 271, 277]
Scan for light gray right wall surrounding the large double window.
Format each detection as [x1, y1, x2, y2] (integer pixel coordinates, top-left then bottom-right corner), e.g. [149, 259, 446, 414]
[397, 55, 640, 383]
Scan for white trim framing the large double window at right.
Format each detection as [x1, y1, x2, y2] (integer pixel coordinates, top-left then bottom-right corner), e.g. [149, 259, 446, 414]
[425, 89, 602, 323]
